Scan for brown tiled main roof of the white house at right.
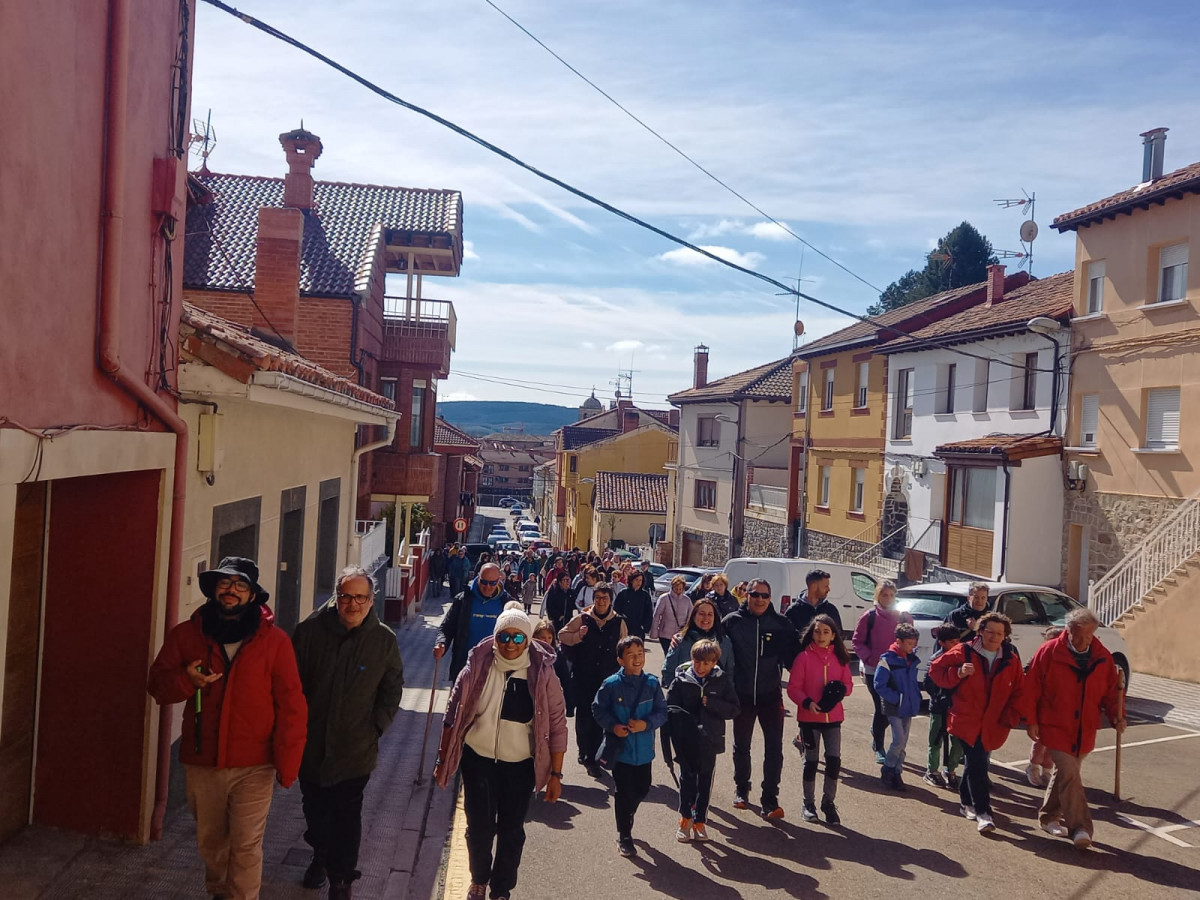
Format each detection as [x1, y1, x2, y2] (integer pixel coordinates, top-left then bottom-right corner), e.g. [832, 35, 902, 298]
[880, 271, 1075, 353]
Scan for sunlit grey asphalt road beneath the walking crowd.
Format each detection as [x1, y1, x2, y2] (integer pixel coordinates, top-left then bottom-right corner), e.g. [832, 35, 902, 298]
[499, 647, 1200, 900]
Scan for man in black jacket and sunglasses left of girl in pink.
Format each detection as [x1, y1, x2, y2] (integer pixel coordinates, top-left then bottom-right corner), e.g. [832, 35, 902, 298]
[721, 578, 799, 818]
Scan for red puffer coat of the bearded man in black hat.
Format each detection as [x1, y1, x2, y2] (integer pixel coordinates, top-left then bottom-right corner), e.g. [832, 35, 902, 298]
[146, 606, 308, 787]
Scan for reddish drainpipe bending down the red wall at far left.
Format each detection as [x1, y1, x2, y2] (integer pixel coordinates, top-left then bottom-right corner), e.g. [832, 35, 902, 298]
[96, 0, 187, 840]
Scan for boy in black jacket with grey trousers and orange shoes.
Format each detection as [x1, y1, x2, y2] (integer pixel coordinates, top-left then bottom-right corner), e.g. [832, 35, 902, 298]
[667, 640, 740, 841]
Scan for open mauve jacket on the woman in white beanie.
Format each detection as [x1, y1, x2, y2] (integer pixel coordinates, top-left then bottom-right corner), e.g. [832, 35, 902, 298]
[438, 637, 566, 791]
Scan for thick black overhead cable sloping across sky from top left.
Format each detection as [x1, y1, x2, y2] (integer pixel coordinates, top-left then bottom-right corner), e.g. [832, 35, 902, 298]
[204, 0, 1050, 372]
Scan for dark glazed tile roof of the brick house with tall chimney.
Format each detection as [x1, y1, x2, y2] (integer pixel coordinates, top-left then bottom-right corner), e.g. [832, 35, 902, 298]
[184, 173, 462, 298]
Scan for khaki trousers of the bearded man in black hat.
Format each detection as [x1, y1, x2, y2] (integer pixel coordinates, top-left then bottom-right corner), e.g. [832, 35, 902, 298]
[184, 766, 275, 900]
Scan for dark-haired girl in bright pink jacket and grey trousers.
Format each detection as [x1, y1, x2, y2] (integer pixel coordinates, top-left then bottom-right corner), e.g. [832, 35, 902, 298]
[787, 616, 854, 824]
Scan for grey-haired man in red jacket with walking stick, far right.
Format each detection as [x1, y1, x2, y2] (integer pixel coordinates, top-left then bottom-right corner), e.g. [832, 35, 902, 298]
[1024, 608, 1126, 850]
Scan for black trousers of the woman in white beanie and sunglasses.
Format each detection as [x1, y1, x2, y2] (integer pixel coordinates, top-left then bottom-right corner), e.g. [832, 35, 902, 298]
[460, 746, 534, 896]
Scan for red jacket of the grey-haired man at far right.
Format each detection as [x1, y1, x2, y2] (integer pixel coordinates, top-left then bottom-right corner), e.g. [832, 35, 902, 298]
[1024, 631, 1120, 756]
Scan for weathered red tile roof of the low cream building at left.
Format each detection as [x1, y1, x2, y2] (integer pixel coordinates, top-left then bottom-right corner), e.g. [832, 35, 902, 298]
[179, 302, 396, 410]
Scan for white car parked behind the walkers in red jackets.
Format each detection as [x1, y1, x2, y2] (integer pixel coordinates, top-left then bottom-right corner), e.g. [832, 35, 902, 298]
[896, 581, 1129, 684]
